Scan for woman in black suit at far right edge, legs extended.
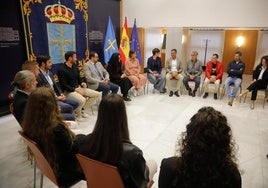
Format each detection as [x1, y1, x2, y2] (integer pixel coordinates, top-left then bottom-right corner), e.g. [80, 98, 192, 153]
[239, 56, 268, 109]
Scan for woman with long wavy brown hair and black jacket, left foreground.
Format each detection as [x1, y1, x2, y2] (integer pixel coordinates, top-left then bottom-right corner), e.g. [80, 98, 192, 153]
[22, 87, 85, 186]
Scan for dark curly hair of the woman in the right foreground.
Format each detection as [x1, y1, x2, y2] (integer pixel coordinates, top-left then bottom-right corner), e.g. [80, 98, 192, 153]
[178, 107, 237, 188]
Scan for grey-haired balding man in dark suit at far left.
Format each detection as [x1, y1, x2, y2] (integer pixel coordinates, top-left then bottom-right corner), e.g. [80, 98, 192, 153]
[12, 70, 37, 125]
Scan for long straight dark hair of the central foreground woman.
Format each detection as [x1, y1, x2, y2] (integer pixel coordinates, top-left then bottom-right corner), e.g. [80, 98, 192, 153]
[80, 94, 129, 165]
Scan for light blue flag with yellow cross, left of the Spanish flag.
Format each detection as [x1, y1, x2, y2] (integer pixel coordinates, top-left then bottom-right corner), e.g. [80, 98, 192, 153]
[103, 16, 118, 64]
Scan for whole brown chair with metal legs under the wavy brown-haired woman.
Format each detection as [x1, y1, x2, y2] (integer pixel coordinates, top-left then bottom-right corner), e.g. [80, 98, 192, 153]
[19, 131, 78, 188]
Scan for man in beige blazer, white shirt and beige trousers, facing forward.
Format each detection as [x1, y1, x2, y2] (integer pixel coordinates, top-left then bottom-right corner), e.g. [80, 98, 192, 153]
[166, 49, 183, 97]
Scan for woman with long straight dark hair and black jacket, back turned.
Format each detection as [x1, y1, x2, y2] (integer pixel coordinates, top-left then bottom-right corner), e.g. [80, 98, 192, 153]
[79, 94, 156, 188]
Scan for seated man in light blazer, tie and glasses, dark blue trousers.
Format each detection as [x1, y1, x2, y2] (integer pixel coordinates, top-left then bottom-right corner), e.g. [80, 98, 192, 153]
[83, 51, 119, 96]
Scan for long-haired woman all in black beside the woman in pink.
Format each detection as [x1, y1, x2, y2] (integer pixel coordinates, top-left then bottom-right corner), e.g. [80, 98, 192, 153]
[107, 53, 132, 101]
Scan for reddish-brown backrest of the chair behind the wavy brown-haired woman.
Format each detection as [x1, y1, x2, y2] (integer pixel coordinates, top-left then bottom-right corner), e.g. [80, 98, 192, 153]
[19, 131, 58, 186]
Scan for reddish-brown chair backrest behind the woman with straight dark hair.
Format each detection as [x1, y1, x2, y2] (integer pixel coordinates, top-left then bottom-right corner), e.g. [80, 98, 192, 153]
[76, 154, 124, 188]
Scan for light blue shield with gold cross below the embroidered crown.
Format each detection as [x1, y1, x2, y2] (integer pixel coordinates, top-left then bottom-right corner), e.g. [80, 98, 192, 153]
[47, 23, 76, 64]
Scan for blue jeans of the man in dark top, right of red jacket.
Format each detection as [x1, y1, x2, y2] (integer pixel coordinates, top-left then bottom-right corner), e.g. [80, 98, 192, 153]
[224, 77, 242, 99]
